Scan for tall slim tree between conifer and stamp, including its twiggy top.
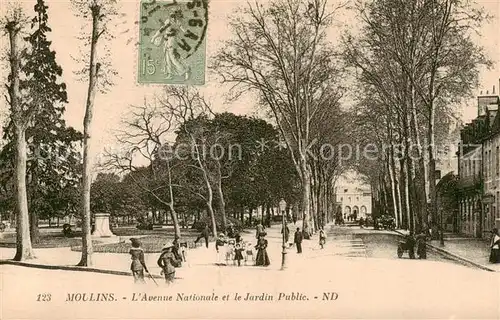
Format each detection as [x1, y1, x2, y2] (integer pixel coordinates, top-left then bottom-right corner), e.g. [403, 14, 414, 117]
[72, 0, 117, 266]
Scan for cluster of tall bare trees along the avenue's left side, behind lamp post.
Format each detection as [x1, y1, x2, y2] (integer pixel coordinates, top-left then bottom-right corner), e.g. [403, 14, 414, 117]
[212, 0, 349, 237]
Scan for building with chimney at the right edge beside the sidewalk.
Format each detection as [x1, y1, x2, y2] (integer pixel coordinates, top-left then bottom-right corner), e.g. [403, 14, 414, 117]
[457, 82, 500, 238]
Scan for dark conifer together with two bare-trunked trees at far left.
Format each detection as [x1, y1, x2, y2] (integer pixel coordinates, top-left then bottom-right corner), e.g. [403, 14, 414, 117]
[0, 0, 116, 266]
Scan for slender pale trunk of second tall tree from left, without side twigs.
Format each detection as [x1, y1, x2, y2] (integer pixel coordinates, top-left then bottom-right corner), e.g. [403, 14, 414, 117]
[78, 4, 101, 267]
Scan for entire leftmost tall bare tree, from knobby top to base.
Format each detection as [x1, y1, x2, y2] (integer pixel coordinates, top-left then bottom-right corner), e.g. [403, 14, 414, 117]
[1, 5, 35, 261]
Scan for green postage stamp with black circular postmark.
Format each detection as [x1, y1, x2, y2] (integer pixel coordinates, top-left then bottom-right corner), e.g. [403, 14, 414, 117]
[138, 0, 208, 85]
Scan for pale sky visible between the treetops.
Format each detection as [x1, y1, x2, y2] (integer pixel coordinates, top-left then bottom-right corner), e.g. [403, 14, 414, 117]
[0, 0, 500, 160]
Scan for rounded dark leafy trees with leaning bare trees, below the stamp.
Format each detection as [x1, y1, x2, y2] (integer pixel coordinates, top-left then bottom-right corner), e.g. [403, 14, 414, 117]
[98, 91, 297, 237]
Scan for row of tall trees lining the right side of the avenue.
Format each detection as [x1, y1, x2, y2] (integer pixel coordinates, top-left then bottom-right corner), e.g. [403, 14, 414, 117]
[344, 0, 490, 236]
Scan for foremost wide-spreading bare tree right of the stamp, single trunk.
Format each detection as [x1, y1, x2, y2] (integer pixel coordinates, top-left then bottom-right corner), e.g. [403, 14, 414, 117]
[211, 0, 346, 237]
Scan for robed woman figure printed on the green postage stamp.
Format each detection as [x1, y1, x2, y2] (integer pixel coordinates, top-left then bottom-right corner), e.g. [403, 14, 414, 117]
[151, 11, 190, 80]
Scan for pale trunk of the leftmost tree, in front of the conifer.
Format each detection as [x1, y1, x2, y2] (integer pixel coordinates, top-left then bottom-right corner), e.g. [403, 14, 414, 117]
[5, 21, 35, 261]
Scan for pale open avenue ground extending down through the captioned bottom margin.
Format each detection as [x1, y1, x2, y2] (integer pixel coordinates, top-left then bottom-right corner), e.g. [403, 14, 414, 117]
[2, 227, 500, 319]
